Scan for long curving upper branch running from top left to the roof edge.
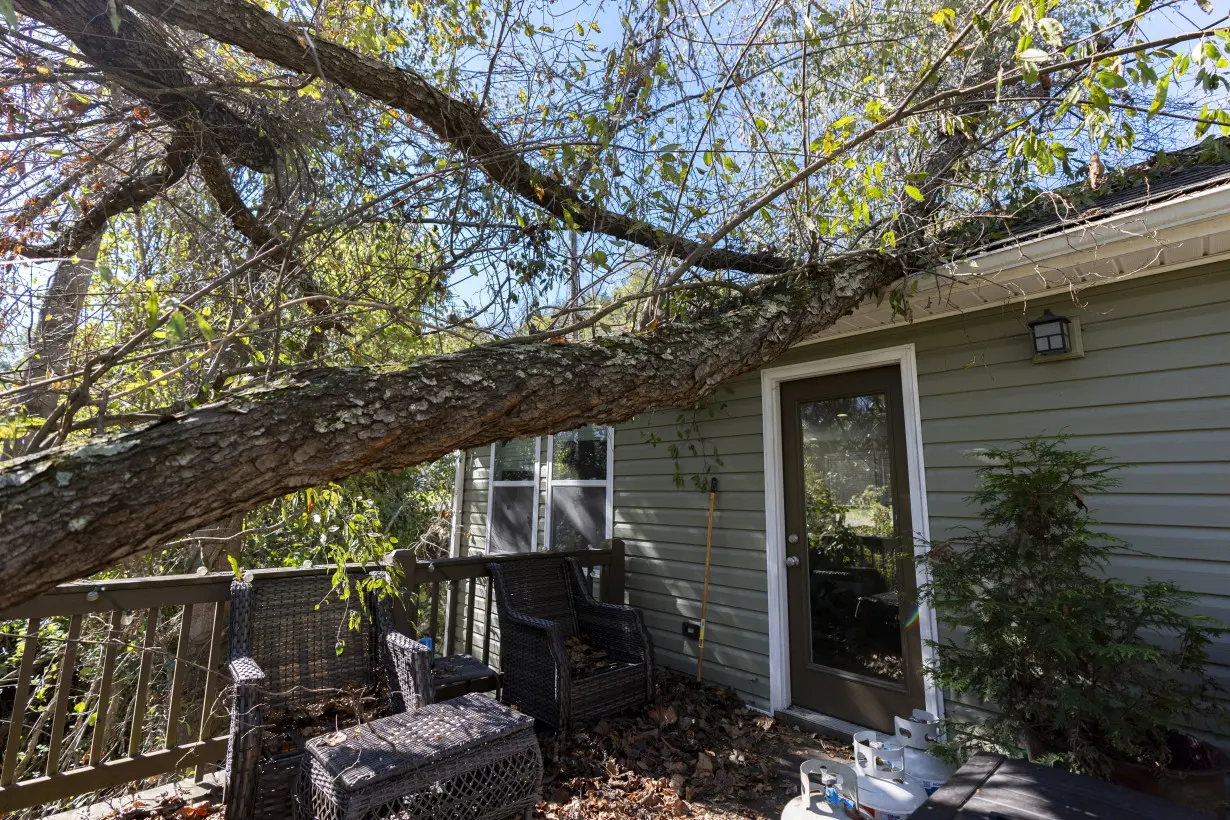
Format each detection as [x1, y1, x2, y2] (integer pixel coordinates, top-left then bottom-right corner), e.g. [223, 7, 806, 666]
[129, 0, 795, 273]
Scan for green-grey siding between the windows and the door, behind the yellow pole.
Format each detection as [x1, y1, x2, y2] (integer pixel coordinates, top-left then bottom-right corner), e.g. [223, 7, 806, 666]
[614, 374, 769, 708]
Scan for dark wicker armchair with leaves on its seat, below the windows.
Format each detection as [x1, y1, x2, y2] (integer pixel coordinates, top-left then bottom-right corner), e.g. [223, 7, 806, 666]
[487, 556, 653, 729]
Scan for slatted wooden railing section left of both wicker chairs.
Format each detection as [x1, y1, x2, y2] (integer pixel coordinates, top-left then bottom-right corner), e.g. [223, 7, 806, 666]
[0, 573, 231, 815]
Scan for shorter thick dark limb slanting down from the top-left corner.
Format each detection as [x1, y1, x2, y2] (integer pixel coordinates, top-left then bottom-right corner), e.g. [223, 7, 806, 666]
[16, 0, 276, 171]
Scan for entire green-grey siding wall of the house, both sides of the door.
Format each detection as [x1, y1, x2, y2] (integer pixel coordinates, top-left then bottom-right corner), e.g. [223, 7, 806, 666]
[464, 263, 1230, 708]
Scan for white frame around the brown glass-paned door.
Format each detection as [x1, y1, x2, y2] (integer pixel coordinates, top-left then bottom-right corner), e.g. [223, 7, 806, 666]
[760, 344, 943, 717]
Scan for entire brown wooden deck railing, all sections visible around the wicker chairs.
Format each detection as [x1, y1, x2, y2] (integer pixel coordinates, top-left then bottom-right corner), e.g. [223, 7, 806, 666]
[0, 540, 624, 816]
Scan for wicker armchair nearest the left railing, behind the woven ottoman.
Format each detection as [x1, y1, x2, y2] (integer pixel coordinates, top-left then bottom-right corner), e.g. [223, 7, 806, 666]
[225, 575, 431, 820]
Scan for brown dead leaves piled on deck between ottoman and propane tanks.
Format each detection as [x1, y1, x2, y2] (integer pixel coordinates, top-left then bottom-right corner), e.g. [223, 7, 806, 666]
[536, 670, 849, 820]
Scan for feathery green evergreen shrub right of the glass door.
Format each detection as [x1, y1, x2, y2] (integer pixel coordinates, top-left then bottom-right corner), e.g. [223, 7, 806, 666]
[921, 439, 1225, 778]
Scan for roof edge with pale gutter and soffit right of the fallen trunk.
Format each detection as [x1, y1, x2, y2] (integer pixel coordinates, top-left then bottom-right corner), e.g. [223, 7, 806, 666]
[804, 141, 1230, 344]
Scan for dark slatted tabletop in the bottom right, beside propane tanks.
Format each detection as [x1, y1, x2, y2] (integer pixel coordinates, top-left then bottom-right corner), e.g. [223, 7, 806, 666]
[910, 752, 1209, 820]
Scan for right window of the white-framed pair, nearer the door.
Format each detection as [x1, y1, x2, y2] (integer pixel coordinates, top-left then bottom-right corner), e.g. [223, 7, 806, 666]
[546, 427, 614, 550]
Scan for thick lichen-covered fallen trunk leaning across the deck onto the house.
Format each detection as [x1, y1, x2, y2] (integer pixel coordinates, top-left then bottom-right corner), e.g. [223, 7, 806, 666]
[0, 253, 907, 609]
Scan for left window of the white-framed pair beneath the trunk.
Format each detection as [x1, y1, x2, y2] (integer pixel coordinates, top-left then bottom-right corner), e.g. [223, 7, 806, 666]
[487, 439, 539, 552]
